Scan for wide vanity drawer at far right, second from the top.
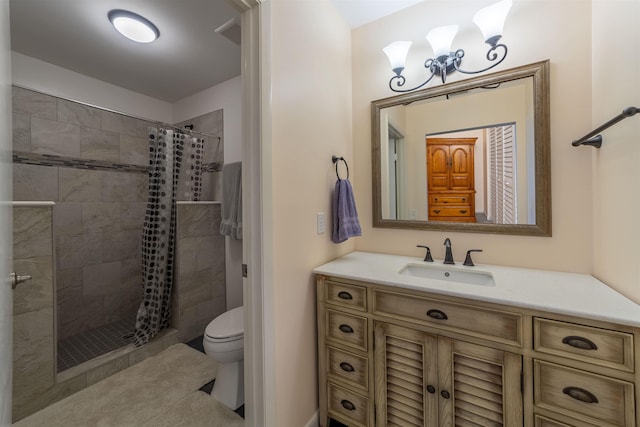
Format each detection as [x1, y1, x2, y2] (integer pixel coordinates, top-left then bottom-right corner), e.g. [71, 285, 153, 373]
[534, 360, 635, 427]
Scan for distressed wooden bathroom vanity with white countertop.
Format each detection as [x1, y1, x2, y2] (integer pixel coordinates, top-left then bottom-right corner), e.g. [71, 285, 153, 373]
[315, 253, 640, 427]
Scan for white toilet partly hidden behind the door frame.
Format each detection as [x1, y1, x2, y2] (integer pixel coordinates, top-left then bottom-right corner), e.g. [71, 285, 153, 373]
[202, 306, 244, 410]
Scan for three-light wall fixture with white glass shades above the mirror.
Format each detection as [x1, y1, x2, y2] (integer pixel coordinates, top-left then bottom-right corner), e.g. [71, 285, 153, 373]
[382, 0, 512, 92]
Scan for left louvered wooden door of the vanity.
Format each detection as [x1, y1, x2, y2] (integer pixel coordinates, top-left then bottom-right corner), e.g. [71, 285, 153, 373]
[374, 322, 438, 427]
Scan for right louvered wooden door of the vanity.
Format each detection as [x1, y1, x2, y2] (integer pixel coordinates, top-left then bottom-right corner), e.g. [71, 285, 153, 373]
[438, 337, 523, 427]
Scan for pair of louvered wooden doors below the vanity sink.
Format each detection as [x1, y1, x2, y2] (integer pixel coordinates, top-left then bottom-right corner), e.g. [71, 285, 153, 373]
[374, 322, 522, 427]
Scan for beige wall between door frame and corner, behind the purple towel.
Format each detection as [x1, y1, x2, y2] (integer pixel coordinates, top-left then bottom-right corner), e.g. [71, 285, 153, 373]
[263, 0, 358, 427]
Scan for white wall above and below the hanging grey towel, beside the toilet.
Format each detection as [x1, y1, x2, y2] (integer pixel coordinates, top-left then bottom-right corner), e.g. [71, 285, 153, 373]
[172, 76, 242, 310]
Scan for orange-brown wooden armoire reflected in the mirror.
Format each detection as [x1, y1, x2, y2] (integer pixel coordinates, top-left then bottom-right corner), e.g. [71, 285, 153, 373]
[427, 138, 477, 222]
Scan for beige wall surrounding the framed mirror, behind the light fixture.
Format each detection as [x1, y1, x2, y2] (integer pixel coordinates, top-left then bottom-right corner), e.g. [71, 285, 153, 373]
[352, 0, 593, 273]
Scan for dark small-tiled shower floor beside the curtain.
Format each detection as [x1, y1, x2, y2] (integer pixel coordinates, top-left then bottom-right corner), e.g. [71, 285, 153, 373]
[58, 320, 134, 372]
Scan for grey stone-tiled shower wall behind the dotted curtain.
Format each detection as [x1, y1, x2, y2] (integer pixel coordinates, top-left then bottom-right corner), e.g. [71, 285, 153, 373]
[13, 87, 222, 339]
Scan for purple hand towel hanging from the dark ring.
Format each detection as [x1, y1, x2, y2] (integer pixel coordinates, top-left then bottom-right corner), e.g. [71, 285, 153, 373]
[331, 179, 362, 243]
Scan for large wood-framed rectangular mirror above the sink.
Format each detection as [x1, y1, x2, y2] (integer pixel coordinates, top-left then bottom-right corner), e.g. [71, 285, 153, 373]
[371, 60, 551, 236]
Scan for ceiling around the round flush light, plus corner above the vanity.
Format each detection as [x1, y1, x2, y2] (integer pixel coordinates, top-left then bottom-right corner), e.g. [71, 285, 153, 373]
[10, 0, 422, 102]
